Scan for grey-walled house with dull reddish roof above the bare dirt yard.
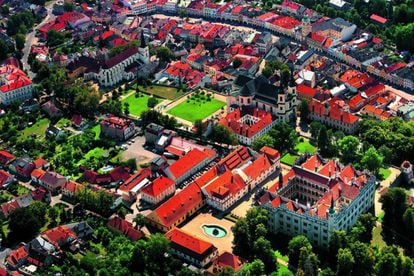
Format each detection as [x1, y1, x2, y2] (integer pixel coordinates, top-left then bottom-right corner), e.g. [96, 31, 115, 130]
[100, 116, 135, 141]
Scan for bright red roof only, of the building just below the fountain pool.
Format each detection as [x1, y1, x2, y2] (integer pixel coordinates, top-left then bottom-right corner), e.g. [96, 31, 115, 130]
[165, 228, 217, 255]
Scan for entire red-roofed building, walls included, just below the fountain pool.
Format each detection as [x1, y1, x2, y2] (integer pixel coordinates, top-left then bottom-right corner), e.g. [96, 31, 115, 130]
[165, 228, 218, 267]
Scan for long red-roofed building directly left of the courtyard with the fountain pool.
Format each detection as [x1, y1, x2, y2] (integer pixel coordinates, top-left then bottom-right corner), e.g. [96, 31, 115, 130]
[146, 182, 204, 232]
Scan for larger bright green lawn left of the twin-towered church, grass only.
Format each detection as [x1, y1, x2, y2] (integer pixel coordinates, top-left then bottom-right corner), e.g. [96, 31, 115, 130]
[168, 99, 226, 123]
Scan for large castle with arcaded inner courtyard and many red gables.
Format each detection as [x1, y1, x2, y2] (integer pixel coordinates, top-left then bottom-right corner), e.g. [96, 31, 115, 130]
[259, 155, 376, 247]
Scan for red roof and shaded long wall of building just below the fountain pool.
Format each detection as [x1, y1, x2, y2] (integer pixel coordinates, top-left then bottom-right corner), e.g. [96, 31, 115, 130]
[165, 228, 217, 261]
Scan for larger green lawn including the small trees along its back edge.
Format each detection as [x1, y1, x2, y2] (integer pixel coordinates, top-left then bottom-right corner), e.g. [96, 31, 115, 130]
[167, 91, 226, 123]
